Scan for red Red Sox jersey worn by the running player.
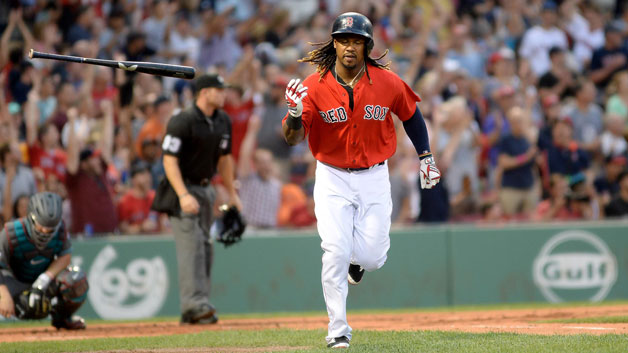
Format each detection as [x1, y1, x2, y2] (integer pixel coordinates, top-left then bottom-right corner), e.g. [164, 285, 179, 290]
[283, 65, 421, 168]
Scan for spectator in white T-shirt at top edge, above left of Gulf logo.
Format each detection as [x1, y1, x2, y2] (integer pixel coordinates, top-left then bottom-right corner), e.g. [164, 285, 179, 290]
[519, 0, 568, 77]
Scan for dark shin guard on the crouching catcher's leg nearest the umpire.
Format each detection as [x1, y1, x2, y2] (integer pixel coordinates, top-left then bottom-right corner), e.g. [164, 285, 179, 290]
[51, 266, 89, 329]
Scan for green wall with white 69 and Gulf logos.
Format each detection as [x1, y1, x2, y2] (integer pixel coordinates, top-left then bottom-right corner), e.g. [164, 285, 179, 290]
[73, 222, 628, 319]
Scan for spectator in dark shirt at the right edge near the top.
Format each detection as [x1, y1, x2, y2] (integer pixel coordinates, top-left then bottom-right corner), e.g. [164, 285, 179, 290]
[590, 23, 628, 89]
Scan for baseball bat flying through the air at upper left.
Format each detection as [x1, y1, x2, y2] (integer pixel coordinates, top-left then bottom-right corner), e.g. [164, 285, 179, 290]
[28, 49, 196, 79]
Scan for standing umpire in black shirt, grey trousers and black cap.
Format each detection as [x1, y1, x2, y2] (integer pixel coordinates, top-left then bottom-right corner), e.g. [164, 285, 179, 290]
[152, 74, 242, 324]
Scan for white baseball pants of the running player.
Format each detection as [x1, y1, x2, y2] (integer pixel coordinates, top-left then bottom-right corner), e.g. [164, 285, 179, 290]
[314, 162, 392, 343]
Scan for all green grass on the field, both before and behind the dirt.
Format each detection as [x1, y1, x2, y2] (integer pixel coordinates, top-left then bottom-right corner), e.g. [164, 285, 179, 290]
[0, 302, 628, 353]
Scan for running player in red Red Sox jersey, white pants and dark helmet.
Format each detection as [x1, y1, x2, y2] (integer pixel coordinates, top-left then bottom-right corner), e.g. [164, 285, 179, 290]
[282, 12, 440, 348]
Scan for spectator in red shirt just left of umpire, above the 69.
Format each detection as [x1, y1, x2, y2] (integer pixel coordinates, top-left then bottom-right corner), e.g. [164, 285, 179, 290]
[118, 161, 160, 234]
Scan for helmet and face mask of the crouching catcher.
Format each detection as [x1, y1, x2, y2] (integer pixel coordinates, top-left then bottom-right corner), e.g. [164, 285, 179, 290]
[26, 192, 63, 250]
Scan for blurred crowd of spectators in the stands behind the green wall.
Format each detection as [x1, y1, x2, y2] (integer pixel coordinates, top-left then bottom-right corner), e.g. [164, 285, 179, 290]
[0, 0, 628, 236]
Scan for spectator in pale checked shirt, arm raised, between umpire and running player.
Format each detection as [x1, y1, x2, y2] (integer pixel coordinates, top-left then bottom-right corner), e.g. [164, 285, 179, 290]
[238, 116, 281, 228]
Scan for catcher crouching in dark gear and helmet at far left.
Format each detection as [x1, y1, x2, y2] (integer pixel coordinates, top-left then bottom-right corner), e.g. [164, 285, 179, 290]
[0, 192, 89, 330]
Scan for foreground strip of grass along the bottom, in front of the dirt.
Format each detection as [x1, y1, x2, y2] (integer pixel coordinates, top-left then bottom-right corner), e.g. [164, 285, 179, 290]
[0, 330, 628, 353]
